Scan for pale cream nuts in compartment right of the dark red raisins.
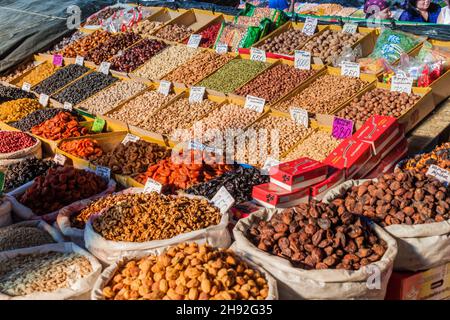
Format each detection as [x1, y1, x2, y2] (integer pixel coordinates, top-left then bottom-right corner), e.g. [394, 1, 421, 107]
[133, 45, 200, 80]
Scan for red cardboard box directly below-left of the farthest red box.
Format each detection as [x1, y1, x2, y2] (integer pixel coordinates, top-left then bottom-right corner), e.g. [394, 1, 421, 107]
[323, 138, 377, 178]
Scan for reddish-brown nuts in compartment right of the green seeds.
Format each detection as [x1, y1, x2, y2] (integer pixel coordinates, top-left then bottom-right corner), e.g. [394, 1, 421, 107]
[235, 64, 315, 103]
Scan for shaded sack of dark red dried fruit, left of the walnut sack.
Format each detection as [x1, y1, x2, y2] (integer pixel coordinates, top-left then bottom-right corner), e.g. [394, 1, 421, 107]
[7, 166, 116, 223]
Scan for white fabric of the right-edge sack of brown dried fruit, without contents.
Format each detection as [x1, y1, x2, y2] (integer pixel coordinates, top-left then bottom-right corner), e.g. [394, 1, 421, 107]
[324, 179, 450, 272]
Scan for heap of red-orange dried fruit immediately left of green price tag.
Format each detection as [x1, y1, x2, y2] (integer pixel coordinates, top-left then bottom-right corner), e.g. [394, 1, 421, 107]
[31, 112, 89, 141]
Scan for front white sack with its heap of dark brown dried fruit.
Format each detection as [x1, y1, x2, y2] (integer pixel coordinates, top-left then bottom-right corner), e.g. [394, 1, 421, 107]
[232, 205, 397, 299]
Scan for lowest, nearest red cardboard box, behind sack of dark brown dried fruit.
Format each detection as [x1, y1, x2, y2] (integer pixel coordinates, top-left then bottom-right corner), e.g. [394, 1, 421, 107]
[252, 183, 309, 208]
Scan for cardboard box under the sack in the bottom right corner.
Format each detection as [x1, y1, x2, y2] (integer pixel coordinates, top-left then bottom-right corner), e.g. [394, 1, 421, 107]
[386, 263, 450, 300]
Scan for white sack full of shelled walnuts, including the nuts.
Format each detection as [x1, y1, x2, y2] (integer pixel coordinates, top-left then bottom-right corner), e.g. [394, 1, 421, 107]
[84, 188, 231, 264]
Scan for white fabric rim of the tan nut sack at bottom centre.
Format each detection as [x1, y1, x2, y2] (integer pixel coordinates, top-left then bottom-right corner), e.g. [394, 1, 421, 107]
[91, 248, 278, 300]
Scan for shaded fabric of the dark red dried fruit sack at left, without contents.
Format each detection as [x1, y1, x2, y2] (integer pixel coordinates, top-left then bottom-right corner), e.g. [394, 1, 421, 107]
[7, 179, 116, 223]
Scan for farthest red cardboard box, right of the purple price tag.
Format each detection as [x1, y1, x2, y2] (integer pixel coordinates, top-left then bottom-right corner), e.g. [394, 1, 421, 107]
[352, 116, 405, 155]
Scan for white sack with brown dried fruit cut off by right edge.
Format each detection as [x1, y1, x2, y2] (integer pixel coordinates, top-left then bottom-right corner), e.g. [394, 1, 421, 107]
[324, 170, 450, 271]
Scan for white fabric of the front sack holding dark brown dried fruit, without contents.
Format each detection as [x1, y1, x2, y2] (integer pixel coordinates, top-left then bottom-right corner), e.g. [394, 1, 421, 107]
[231, 209, 397, 300]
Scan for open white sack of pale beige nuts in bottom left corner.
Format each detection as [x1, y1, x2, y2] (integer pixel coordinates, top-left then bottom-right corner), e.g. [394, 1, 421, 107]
[0, 242, 102, 300]
